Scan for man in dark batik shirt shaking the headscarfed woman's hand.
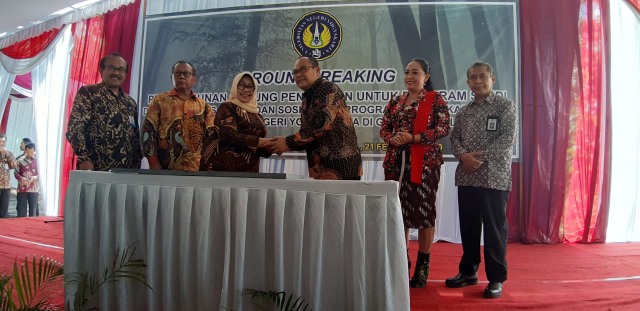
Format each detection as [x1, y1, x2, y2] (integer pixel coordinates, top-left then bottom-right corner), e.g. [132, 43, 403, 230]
[269, 57, 362, 180]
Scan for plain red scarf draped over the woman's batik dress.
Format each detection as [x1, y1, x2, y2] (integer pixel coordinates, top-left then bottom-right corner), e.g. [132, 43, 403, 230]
[411, 91, 436, 184]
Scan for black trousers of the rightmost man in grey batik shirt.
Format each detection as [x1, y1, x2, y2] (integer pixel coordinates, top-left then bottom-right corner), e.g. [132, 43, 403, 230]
[458, 187, 509, 282]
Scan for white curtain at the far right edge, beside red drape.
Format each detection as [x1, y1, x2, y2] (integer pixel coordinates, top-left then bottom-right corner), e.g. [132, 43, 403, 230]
[607, 0, 640, 242]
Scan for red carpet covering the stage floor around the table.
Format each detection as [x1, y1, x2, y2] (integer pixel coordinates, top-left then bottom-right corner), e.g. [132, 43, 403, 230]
[0, 217, 640, 311]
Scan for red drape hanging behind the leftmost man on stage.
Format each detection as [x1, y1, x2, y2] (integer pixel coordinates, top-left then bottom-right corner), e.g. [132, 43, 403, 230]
[58, 0, 140, 216]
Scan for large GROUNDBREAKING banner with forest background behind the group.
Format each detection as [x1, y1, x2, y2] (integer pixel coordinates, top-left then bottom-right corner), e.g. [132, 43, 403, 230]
[138, 1, 520, 159]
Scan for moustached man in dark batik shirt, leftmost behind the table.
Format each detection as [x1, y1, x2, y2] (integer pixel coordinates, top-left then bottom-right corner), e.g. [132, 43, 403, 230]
[67, 53, 142, 171]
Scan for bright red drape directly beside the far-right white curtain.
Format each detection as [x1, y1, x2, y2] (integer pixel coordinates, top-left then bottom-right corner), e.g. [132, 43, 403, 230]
[563, 0, 611, 242]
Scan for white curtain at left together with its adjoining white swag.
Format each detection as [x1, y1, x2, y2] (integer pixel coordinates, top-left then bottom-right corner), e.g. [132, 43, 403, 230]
[0, 26, 73, 216]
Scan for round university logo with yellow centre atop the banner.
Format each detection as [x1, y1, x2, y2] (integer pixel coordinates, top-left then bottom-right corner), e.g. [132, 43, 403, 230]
[291, 11, 342, 60]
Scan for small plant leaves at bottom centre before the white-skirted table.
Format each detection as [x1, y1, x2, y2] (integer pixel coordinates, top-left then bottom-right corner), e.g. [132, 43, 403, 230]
[242, 289, 313, 311]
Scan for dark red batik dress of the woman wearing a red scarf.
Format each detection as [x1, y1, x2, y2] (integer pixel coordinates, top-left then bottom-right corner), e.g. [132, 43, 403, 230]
[380, 90, 450, 229]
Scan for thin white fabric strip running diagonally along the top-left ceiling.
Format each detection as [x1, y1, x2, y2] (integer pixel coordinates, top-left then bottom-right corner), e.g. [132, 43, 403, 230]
[0, 0, 135, 49]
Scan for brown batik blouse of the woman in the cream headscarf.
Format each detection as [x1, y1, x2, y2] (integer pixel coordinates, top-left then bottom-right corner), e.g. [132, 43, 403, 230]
[201, 102, 271, 173]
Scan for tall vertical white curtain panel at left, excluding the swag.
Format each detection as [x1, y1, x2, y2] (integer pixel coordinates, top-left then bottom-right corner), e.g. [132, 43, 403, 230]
[31, 26, 73, 216]
